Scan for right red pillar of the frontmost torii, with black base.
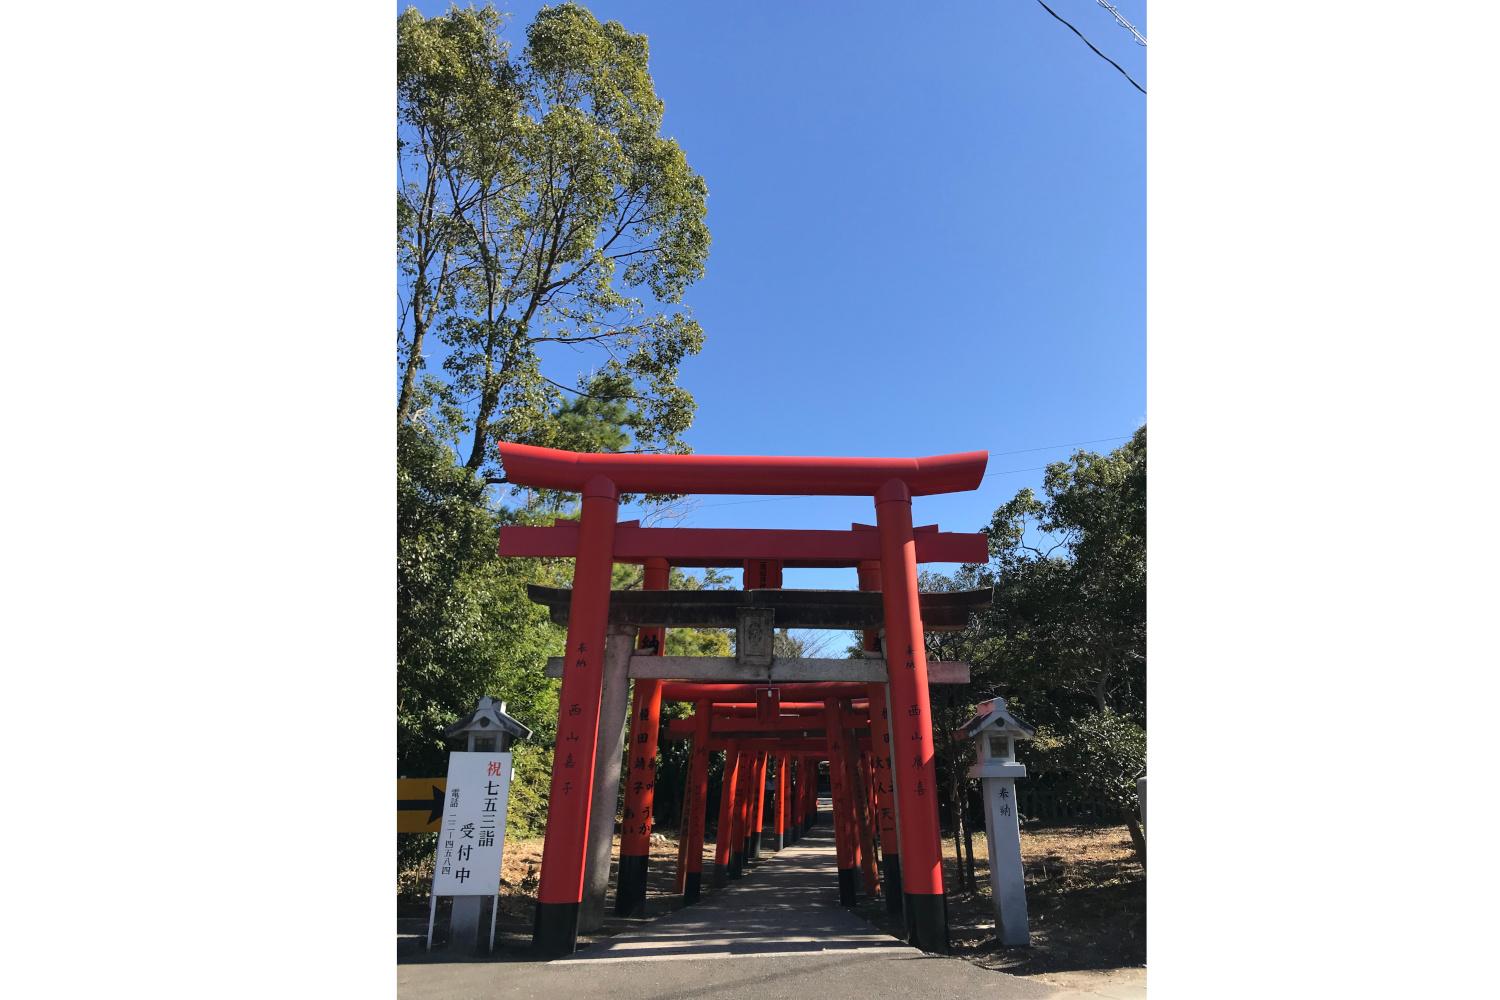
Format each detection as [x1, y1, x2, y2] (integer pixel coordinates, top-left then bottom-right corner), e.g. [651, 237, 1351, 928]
[875, 480, 948, 954]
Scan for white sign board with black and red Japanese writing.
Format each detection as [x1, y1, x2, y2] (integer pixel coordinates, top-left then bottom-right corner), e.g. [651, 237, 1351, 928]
[432, 753, 513, 900]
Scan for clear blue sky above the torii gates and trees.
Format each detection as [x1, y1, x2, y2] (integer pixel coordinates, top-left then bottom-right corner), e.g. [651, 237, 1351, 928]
[405, 0, 1149, 588]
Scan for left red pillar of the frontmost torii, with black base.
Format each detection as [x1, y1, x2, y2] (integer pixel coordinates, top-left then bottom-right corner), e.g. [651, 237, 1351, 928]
[533, 475, 620, 954]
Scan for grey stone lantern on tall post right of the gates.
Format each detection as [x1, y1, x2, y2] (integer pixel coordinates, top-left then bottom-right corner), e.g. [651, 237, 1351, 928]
[959, 697, 1037, 946]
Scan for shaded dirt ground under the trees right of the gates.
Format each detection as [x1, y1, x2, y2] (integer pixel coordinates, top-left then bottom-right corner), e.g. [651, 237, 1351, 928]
[860, 825, 1146, 981]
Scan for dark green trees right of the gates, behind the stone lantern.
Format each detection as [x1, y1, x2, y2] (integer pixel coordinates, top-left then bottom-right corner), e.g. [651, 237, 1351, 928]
[921, 427, 1146, 859]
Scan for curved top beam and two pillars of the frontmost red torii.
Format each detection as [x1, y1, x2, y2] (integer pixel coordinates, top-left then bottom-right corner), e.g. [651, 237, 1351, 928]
[500, 442, 989, 954]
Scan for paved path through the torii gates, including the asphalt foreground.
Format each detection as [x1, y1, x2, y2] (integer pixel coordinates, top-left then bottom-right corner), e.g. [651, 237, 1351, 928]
[398, 813, 1088, 1000]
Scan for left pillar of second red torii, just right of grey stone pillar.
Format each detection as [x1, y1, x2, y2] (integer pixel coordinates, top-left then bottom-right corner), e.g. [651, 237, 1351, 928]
[615, 559, 671, 916]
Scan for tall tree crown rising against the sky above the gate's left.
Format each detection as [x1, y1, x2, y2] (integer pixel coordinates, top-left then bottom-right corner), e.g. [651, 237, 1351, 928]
[402, 4, 710, 472]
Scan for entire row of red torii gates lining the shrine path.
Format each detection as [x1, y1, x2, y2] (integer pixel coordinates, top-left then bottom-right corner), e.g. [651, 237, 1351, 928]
[500, 442, 990, 954]
